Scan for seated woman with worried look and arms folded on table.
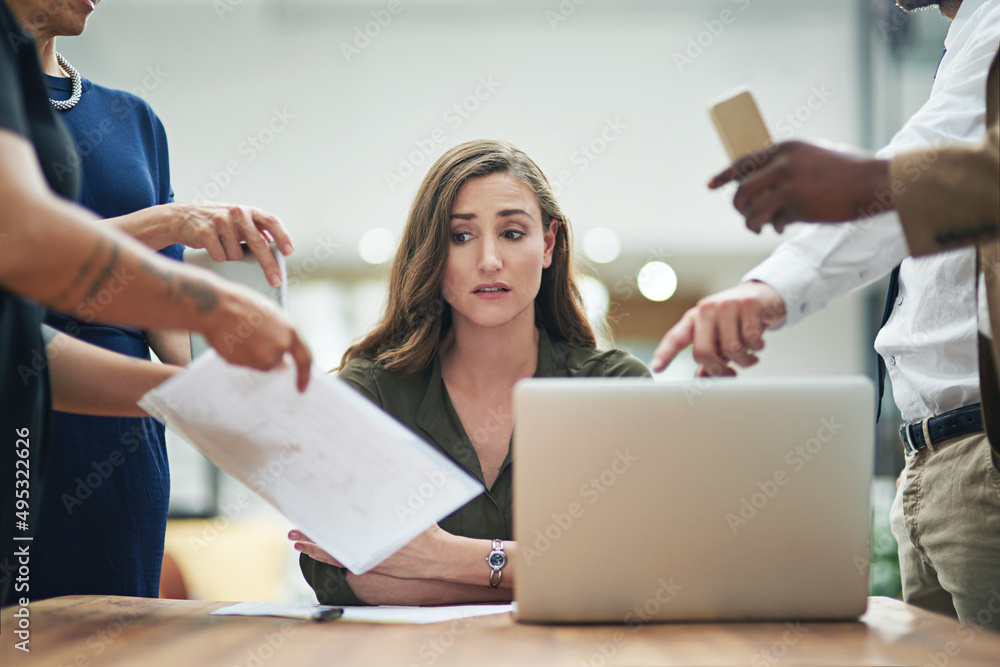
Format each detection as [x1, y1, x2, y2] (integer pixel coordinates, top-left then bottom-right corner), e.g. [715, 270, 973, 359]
[289, 141, 649, 605]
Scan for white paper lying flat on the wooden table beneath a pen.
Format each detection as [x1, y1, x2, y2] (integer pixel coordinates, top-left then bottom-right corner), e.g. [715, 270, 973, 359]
[210, 602, 512, 624]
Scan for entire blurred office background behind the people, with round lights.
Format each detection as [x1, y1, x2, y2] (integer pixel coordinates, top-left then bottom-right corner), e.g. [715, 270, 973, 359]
[59, 0, 948, 600]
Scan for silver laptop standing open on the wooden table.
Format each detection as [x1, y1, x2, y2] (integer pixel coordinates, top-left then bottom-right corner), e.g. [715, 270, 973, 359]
[513, 377, 874, 626]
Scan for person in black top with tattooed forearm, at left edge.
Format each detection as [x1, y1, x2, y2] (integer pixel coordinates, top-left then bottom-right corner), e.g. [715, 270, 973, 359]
[0, 0, 311, 606]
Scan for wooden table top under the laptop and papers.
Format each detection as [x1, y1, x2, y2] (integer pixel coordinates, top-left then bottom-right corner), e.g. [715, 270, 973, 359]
[0, 596, 1000, 667]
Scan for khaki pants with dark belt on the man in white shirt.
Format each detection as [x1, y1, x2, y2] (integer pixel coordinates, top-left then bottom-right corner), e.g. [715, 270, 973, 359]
[889, 433, 1000, 630]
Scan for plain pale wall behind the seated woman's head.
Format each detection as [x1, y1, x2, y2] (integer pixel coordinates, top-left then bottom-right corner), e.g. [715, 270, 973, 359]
[60, 0, 868, 374]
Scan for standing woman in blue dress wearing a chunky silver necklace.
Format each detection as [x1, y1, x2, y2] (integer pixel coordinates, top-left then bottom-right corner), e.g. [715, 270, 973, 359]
[8, 0, 292, 599]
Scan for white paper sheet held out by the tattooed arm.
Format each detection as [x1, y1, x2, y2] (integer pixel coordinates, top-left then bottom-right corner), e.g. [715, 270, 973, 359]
[139, 351, 483, 574]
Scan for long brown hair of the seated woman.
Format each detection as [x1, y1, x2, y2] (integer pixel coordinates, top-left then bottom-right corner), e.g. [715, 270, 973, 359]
[341, 140, 596, 375]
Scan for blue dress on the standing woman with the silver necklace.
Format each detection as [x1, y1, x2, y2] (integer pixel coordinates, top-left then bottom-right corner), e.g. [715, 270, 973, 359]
[31, 76, 183, 600]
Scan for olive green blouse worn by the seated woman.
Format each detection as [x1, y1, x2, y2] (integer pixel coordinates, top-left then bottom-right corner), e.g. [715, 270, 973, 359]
[299, 329, 650, 606]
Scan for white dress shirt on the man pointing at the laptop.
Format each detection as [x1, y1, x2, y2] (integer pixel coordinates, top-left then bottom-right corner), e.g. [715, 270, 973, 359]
[743, 0, 1000, 420]
